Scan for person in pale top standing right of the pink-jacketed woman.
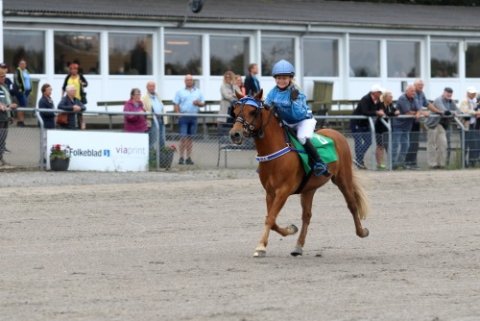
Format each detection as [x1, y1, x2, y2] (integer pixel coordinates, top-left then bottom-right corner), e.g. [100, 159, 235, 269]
[142, 81, 165, 148]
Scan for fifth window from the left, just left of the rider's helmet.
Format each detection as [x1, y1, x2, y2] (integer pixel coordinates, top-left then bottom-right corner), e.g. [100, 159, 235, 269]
[210, 36, 250, 75]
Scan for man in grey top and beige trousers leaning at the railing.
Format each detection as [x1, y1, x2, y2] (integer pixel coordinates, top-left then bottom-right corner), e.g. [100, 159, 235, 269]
[425, 87, 458, 169]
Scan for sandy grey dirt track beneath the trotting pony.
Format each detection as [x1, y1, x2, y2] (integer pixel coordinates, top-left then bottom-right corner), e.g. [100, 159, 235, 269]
[0, 170, 480, 321]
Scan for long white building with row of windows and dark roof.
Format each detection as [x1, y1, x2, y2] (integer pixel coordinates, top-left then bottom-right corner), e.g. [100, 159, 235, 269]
[0, 0, 480, 110]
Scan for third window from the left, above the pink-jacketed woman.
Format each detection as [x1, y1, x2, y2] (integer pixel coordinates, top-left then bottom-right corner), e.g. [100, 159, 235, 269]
[108, 33, 152, 75]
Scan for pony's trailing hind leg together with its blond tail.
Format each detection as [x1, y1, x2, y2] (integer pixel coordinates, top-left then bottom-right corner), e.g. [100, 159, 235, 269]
[332, 170, 369, 238]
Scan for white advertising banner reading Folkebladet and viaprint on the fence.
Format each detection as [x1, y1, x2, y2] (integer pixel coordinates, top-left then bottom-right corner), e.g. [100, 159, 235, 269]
[45, 130, 149, 172]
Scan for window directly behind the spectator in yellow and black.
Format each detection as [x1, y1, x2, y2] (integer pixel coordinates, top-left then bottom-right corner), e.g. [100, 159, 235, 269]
[54, 32, 100, 74]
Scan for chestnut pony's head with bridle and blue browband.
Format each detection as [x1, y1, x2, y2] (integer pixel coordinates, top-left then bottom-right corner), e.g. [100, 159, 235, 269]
[230, 90, 263, 145]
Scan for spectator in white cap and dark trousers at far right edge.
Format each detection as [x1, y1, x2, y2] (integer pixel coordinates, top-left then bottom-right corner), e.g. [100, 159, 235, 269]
[459, 87, 480, 167]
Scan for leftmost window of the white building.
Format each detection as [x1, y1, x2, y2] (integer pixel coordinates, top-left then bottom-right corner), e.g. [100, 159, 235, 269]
[3, 30, 45, 74]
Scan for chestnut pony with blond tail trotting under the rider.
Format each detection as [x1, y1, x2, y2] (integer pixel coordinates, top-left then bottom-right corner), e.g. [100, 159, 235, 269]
[230, 91, 368, 257]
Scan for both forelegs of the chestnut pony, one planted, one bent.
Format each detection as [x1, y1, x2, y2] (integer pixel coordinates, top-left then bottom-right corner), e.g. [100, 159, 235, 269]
[253, 193, 292, 257]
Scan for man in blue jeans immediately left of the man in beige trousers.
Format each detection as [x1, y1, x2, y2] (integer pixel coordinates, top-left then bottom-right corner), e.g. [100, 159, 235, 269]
[405, 79, 433, 169]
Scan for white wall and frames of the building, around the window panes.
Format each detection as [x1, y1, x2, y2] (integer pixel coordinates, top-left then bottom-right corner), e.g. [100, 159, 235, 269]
[4, 17, 480, 110]
